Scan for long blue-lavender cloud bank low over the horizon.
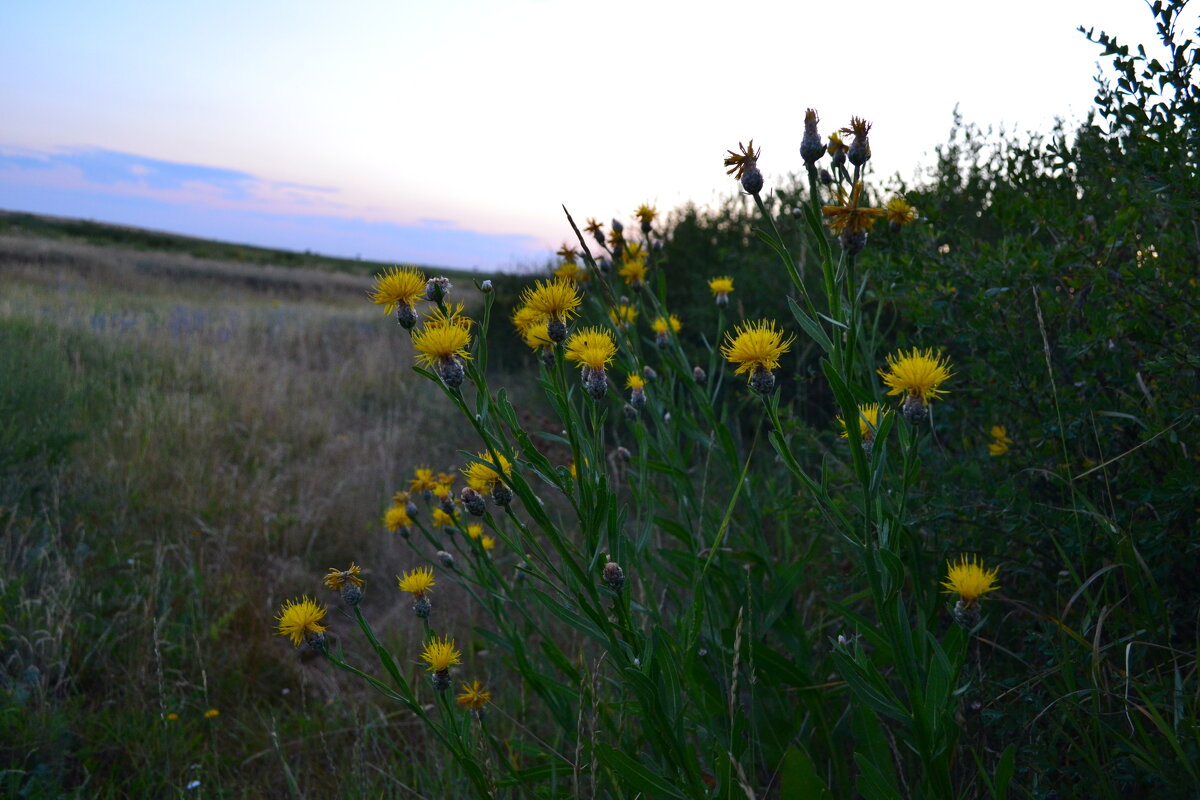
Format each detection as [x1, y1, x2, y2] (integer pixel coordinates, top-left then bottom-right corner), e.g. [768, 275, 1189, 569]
[0, 148, 542, 267]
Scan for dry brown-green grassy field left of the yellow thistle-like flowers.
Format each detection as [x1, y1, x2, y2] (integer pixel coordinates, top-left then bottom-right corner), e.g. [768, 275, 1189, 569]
[0, 235, 501, 796]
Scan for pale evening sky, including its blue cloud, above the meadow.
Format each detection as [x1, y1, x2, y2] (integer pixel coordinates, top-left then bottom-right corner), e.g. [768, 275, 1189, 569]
[0, 0, 1180, 270]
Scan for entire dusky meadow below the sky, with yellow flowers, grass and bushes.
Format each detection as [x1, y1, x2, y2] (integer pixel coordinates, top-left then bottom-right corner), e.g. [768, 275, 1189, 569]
[0, 4, 1200, 800]
